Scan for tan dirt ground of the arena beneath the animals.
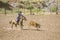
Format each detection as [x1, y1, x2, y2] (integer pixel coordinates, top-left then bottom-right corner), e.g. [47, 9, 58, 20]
[0, 14, 60, 40]
